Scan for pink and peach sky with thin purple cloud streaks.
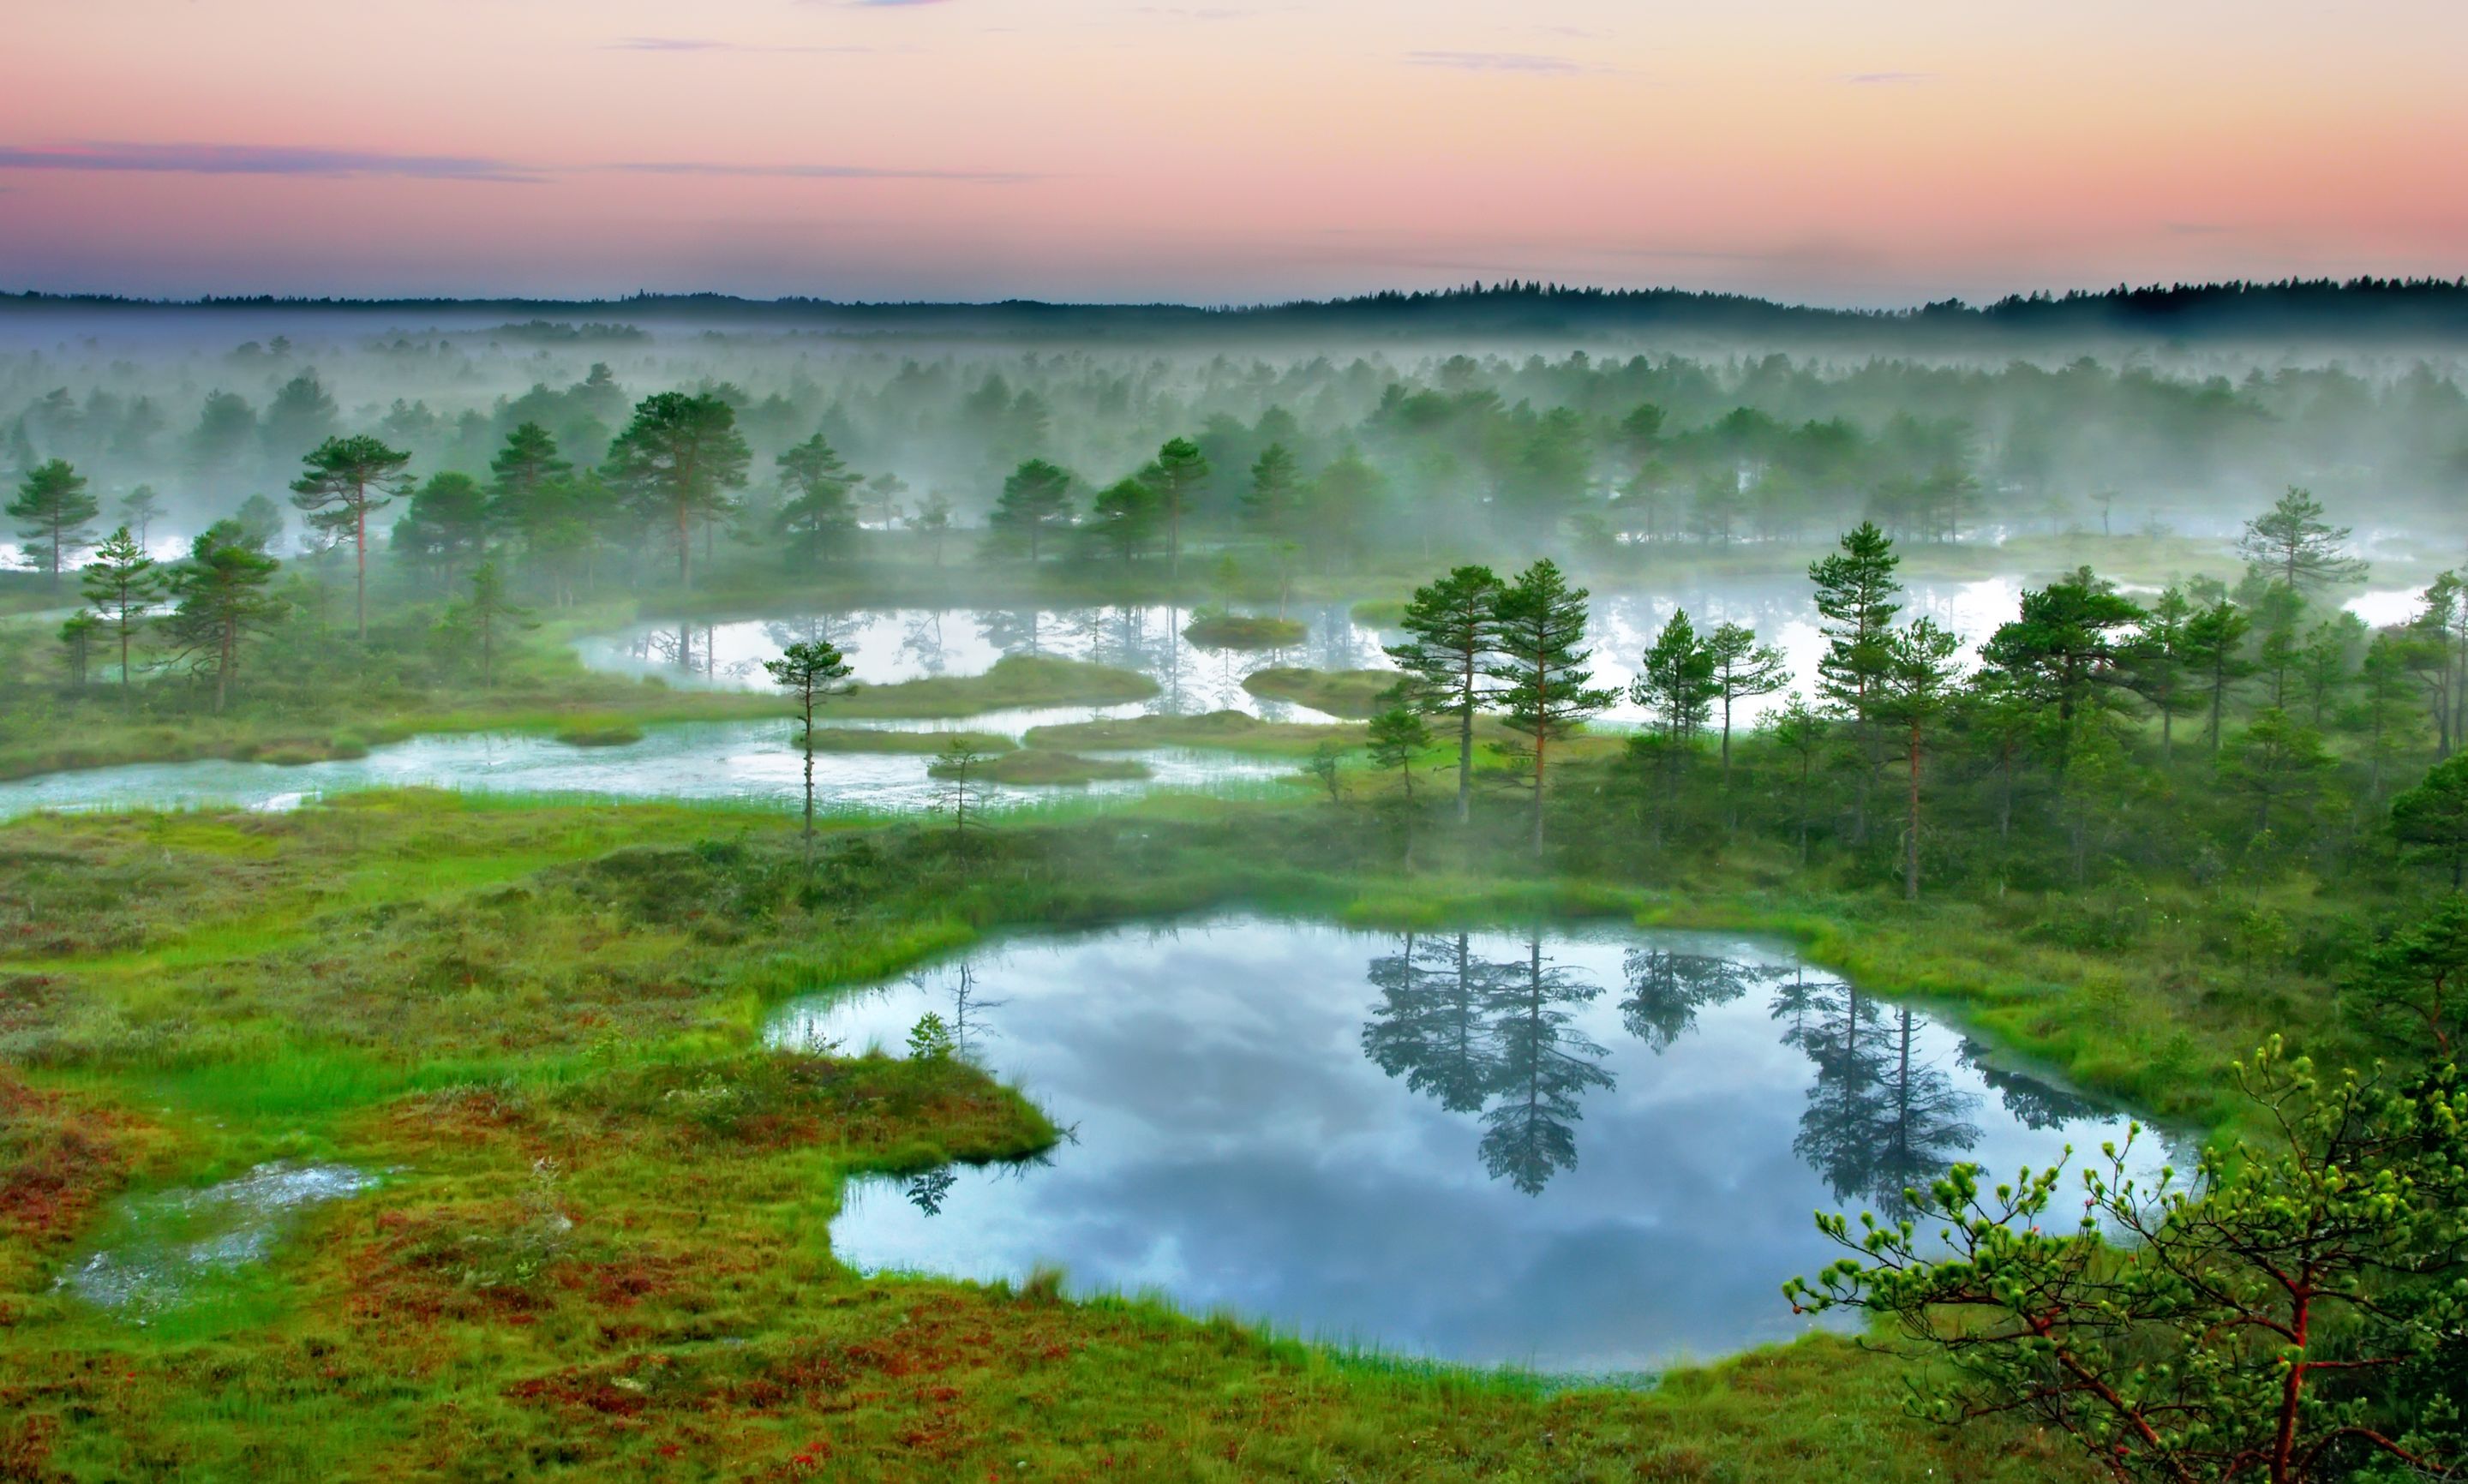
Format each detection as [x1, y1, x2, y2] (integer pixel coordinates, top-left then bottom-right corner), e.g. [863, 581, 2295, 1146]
[0, 0, 2468, 306]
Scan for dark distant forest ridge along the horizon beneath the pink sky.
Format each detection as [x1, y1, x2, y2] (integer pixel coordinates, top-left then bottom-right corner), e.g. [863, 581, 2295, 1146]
[14, 279, 2468, 345]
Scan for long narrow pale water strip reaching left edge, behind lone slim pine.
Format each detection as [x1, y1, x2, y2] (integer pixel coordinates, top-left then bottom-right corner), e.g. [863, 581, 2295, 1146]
[0, 721, 1293, 817]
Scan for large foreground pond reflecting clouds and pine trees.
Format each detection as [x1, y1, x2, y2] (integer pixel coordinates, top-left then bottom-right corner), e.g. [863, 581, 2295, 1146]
[770, 916, 2125, 1373]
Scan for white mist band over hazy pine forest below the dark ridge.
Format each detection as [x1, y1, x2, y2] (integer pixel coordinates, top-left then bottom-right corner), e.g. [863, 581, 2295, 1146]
[0, 302, 2468, 565]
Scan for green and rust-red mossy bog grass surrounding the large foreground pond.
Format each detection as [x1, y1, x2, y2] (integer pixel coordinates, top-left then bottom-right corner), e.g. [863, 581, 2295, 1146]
[0, 793, 2359, 1484]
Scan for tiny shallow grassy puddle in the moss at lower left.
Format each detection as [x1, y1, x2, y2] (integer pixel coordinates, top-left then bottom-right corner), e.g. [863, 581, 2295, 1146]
[59, 1163, 378, 1319]
